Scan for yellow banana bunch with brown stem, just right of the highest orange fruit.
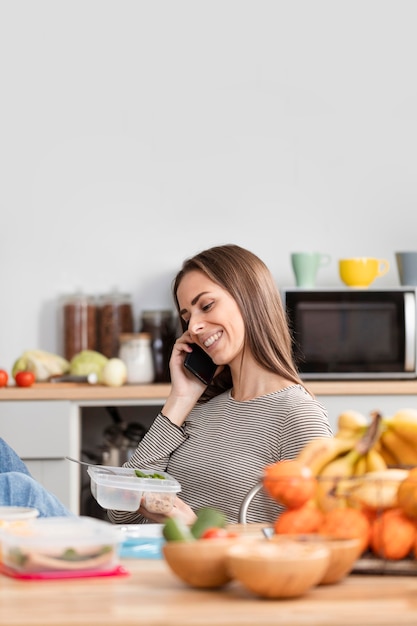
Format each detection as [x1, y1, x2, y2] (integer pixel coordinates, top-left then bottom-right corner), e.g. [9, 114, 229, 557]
[297, 412, 387, 511]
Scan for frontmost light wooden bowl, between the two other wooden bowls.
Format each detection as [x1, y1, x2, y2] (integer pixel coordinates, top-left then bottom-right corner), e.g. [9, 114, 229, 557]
[227, 539, 330, 598]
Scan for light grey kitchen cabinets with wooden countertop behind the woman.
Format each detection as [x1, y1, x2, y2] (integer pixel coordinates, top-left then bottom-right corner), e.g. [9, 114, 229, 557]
[0, 381, 417, 513]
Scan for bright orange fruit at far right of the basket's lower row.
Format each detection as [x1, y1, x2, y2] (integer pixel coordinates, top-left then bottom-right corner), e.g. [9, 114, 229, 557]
[370, 508, 417, 561]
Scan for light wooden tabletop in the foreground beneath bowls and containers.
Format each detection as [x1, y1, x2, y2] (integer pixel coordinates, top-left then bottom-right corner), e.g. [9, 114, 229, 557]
[0, 559, 417, 626]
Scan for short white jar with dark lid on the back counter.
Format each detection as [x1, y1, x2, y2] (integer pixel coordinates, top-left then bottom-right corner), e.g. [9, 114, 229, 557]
[119, 333, 155, 384]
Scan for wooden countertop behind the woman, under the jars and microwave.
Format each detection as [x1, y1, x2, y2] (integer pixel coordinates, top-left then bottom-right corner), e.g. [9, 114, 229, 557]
[0, 380, 417, 402]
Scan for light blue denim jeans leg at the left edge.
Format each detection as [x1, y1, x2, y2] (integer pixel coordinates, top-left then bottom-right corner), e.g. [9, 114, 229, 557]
[0, 438, 72, 517]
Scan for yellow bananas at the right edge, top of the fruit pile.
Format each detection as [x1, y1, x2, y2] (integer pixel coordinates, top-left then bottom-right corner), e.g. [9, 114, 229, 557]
[379, 409, 417, 466]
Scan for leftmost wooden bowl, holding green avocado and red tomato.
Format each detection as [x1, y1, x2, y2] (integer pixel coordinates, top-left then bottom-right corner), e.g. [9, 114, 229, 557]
[162, 538, 238, 588]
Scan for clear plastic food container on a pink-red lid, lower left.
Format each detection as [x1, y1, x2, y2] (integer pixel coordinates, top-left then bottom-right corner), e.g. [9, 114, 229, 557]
[0, 517, 121, 573]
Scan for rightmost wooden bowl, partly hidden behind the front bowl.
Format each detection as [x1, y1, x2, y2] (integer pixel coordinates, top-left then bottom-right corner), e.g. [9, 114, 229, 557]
[271, 534, 362, 585]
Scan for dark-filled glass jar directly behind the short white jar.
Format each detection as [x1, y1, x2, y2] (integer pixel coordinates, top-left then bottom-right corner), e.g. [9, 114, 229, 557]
[98, 291, 133, 359]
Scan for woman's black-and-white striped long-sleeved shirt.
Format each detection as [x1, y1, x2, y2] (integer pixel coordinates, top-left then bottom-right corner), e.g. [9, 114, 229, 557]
[108, 385, 332, 524]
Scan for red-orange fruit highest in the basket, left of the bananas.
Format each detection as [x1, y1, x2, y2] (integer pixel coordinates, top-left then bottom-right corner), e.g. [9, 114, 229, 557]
[263, 459, 317, 509]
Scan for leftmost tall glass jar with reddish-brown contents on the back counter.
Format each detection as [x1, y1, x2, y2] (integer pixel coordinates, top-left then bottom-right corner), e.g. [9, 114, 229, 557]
[61, 292, 97, 361]
